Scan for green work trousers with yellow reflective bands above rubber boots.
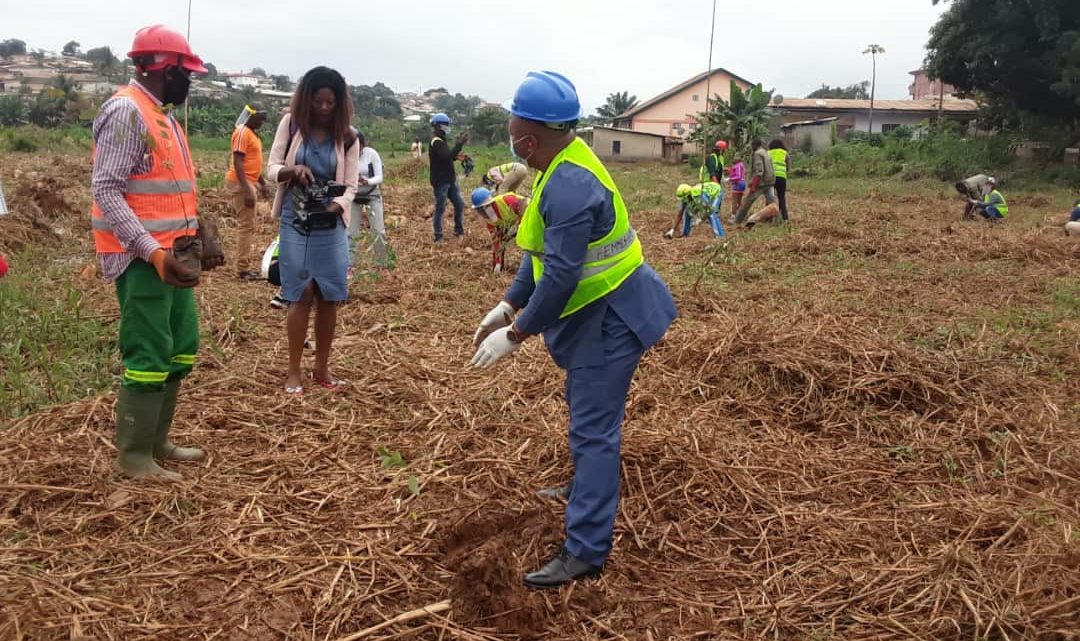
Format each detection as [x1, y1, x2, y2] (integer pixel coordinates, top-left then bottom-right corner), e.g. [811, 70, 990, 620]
[117, 258, 199, 392]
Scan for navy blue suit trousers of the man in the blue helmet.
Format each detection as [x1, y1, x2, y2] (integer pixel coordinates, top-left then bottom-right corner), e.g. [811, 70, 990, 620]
[566, 309, 645, 565]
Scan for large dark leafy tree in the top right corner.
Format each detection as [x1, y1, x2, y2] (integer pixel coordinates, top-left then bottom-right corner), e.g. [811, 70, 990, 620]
[927, 0, 1080, 129]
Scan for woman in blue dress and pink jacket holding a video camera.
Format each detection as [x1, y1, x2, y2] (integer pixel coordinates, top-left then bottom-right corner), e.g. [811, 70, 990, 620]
[267, 67, 360, 395]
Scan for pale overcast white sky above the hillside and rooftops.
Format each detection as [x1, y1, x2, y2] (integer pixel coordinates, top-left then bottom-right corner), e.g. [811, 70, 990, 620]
[0, 0, 944, 110]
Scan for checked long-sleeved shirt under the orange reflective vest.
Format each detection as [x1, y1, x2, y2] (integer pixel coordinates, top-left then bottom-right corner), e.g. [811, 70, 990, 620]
[90, 80, 180, 282]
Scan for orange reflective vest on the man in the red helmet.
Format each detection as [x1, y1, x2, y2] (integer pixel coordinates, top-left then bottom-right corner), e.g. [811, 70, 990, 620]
[91, 85, 199, 254]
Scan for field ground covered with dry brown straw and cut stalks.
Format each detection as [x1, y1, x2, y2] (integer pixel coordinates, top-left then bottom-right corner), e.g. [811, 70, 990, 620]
[0, 146, 1080, 641]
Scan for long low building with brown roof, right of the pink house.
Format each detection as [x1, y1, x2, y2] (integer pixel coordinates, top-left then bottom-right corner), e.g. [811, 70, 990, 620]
[773, 98, 978, 137]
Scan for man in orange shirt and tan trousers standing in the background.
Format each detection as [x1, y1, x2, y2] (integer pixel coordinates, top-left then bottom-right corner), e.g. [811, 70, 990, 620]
[225, 105, 270, 281]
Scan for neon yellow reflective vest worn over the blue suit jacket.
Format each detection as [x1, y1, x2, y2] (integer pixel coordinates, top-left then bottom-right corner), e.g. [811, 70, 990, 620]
[517, 138, 645, 318]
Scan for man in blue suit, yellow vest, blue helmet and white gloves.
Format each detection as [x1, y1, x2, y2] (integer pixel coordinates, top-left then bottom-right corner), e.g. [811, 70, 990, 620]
[472, 71, 676, 588]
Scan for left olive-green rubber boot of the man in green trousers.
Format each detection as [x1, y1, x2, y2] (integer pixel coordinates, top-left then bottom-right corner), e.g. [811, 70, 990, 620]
[117, 387, 183, 480]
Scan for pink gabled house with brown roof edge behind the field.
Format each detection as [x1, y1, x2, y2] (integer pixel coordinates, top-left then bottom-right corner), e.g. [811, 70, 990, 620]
[615, 68, 754, 138]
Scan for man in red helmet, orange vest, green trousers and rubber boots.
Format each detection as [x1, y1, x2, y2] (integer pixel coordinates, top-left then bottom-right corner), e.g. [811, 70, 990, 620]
[91, 25, 206, 480]
